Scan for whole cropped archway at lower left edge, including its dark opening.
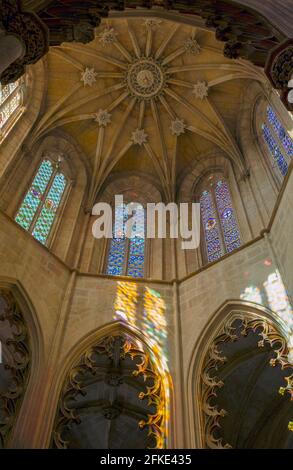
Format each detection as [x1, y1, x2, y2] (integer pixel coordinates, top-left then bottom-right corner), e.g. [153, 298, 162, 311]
[0, 279, 44, 448]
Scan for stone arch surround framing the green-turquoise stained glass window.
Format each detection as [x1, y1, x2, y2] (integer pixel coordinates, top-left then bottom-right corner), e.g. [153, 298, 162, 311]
[0, 132, 90, 263]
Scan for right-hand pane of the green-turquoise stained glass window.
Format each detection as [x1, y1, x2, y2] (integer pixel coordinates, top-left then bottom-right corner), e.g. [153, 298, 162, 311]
[32, 173, 66, 244]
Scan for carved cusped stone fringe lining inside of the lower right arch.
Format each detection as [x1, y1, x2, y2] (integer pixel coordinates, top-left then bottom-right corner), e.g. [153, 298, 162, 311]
[200, 313, 293, 449]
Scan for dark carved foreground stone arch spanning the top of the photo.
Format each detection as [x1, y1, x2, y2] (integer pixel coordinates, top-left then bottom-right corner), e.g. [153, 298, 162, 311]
[0, 0, 285, 83]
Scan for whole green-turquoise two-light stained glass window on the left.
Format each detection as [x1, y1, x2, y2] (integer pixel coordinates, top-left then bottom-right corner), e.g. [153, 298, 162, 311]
[15, 159, 67, 245]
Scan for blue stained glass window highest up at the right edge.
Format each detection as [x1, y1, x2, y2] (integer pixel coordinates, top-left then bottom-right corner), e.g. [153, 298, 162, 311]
[262, 105, 293, 177]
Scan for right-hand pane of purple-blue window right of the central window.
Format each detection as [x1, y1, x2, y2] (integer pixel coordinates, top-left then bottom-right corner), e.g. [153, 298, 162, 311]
[215, 180, 241, 253]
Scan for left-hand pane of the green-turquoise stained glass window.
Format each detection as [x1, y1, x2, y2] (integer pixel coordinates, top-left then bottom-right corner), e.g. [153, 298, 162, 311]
[15, 160, 53, 230]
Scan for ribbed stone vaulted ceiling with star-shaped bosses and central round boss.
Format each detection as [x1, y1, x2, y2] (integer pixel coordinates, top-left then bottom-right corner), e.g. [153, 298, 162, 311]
[30, 17, 266, 200]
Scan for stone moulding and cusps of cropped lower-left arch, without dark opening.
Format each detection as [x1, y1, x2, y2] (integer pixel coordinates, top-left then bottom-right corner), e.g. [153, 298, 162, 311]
[0, 278, 45, 448]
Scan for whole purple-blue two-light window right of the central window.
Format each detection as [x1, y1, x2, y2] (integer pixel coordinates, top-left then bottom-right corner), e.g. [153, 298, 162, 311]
[200, 178, 241, 262]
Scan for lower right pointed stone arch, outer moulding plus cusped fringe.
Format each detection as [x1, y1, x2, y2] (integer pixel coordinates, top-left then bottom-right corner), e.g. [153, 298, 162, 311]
[187, 300, 293, 448]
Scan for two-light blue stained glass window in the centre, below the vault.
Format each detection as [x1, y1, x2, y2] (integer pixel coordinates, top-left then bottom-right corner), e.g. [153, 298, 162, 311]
[107, 205, 145, 277]
